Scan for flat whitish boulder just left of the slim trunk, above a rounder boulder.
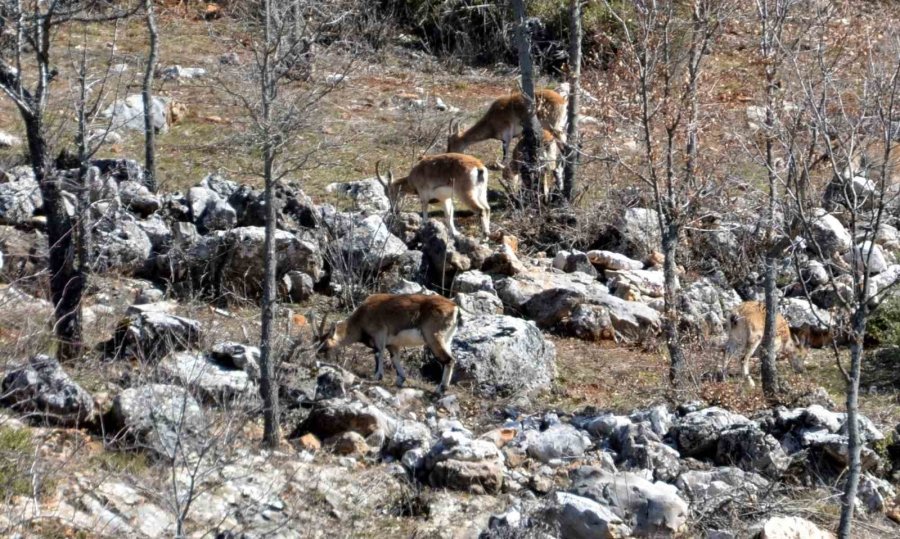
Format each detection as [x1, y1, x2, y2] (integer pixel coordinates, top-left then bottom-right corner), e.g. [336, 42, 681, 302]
[159, 352, 256, 404]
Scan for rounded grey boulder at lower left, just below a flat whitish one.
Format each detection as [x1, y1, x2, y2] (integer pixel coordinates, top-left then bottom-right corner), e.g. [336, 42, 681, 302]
[111, 384, 206, 459]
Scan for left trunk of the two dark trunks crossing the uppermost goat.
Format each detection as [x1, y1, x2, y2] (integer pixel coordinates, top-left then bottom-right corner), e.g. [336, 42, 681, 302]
[512, 0, 543, 203]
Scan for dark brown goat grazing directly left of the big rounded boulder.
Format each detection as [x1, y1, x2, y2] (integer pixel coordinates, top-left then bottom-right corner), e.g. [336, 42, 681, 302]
[319, 294, 461, 393]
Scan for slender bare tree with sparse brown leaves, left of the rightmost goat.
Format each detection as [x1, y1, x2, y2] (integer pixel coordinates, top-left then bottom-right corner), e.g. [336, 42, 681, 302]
[606, 0, 726, 387]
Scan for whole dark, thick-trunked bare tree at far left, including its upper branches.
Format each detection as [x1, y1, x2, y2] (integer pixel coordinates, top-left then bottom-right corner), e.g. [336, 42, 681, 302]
[0, 0, 139, 360]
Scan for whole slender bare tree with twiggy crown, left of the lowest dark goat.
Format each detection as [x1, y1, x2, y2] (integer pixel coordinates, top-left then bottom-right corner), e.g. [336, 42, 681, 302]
[221, 0, 354, 447]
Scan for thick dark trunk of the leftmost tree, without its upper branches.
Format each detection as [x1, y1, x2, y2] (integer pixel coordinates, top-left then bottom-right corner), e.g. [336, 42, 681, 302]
[25, 117, 84, 361]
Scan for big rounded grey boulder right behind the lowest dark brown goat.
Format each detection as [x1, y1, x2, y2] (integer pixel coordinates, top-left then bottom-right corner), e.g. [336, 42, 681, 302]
[426, 315, 556, 396]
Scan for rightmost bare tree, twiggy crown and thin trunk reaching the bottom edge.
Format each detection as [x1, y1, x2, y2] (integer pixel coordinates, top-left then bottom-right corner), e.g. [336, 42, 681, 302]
[783, 5, 900, 538]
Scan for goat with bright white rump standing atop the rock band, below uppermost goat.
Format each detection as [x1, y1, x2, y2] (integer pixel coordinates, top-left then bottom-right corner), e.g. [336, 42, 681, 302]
[375, 153, 491, 236]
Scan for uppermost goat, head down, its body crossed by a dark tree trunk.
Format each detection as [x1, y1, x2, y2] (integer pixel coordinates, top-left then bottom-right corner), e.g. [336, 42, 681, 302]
[447, 89, 566, 164]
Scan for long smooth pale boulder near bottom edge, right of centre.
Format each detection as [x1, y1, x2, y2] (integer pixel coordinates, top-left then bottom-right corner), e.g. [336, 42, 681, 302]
[571, 466, 688, 537]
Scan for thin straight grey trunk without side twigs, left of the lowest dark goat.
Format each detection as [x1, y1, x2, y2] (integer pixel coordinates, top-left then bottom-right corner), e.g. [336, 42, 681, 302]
[259, 0, 281, 448]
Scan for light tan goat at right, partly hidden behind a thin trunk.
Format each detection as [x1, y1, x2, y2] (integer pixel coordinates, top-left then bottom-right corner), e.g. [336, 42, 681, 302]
[721, 301, 804, 387]
